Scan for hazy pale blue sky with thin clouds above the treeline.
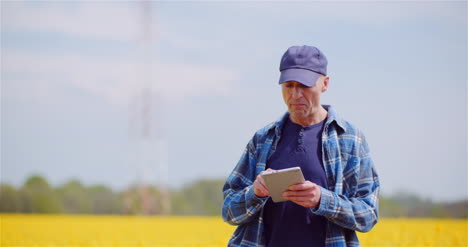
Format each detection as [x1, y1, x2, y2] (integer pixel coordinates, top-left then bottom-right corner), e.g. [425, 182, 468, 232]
[0, 1, 468, 201]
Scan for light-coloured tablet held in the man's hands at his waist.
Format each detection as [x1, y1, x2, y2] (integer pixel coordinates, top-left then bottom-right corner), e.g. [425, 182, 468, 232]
[262, 166, 305, 202]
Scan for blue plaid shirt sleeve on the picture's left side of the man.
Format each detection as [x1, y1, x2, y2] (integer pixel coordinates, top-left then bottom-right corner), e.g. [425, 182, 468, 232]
[222, 139, 268, 225]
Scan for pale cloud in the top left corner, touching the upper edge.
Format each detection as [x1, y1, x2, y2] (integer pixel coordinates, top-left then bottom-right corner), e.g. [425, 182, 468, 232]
[2, 1, 210, 49]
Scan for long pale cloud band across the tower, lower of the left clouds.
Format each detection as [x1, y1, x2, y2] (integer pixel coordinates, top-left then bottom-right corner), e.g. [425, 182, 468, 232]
[2, 51, 237, 104]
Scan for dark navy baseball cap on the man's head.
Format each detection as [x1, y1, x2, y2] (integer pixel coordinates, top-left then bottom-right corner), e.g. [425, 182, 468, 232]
[279, 45, 328, 87]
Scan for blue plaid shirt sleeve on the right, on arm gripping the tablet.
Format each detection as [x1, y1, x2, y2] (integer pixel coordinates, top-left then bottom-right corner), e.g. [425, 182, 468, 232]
[311, 131, 380, 232]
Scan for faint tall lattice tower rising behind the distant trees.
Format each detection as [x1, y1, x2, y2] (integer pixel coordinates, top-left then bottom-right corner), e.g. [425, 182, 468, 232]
[127, 1, 170, 214]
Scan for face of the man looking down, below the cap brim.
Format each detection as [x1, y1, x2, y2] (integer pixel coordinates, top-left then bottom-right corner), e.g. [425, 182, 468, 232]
[281, 76, 329, 119]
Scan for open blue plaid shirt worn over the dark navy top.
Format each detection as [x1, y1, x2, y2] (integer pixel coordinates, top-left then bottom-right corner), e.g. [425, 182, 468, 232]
[222, 105, 380, 247]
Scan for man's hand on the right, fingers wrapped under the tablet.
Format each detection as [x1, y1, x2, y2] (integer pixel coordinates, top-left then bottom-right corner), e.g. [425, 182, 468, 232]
[283, 181, 322, 208]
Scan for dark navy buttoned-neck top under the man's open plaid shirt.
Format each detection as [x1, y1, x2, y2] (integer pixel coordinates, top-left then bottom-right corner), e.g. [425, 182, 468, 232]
[263, 119, 327, 247]
